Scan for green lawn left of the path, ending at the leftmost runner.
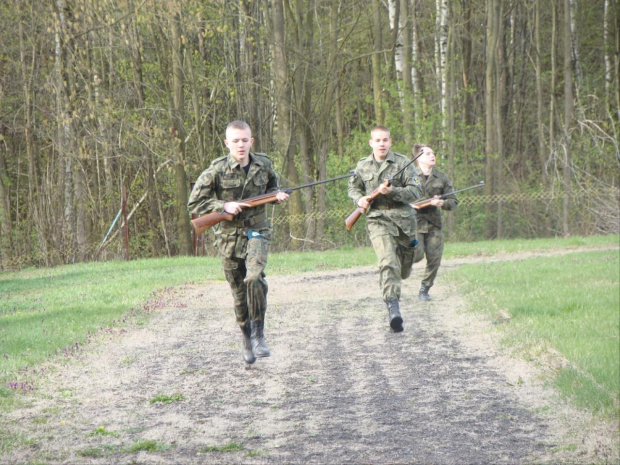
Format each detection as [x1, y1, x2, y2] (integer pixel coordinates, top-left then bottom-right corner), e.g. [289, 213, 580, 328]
[0, 257, 222, 386]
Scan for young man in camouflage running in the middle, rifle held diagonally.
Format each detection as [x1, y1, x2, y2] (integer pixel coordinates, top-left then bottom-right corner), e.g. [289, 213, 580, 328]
[348, 126, 422, 332]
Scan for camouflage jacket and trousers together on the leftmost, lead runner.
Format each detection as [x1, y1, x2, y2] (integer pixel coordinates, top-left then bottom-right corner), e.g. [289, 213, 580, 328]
[188, 152, 278, 325]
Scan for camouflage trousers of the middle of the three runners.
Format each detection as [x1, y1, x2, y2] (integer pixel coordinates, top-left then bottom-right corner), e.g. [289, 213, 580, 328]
[367, 222, 415, 302]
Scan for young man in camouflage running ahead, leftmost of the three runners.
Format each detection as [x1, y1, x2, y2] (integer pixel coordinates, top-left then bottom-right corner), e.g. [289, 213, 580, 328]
[187, 121, 288, 363]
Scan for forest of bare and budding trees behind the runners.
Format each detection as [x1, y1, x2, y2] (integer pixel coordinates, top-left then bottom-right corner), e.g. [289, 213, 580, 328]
[0, 0, 620, 270]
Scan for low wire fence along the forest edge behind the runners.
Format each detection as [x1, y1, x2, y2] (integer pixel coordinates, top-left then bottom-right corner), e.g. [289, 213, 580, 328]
[0, 187, 620, 270]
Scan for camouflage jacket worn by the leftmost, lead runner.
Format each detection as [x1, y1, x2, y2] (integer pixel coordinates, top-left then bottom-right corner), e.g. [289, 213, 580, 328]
[187, 152, 278, 257]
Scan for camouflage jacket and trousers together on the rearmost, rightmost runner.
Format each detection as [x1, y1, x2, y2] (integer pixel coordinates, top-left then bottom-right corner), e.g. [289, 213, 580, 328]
[414, 168, 459, 291]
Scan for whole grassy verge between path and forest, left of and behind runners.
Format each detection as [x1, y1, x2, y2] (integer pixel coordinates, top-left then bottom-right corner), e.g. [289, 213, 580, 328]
[0, 236, 618, 408]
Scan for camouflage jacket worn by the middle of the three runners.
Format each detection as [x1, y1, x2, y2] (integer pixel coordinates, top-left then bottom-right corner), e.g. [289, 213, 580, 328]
[348, 151, 422, 236]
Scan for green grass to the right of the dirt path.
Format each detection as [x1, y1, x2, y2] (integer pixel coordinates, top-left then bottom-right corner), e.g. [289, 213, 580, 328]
[448, 246, 620, 418]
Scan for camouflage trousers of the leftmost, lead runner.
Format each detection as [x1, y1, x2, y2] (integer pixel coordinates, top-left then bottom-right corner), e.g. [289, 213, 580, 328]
[222, 238, 269, 325]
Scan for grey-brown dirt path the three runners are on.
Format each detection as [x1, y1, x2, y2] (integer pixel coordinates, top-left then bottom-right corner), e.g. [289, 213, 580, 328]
[0, 252, 618, 464]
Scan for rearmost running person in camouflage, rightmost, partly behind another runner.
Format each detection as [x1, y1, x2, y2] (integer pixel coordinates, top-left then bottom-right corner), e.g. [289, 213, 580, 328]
[413, 144, 459, 301]
